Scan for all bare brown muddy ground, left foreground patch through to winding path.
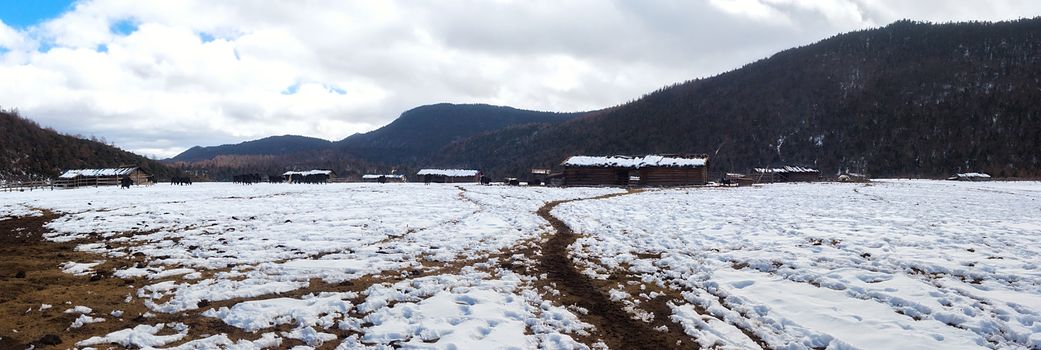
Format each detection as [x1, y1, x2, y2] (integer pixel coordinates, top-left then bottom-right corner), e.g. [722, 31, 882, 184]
[0, 189, 699, 350]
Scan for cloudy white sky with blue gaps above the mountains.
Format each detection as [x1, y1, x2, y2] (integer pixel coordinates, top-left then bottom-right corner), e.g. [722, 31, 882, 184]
[0, 0, 1041, 158]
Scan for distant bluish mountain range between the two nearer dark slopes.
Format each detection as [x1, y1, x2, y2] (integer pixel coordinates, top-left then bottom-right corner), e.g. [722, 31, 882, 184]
[163, 103, 580, 179]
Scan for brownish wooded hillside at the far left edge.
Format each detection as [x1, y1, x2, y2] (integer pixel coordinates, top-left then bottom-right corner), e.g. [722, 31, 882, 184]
[0, 110, 171, 181]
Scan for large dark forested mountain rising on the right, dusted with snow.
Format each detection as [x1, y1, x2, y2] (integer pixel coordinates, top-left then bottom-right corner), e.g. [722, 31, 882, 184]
[431, 18, 1041, 177]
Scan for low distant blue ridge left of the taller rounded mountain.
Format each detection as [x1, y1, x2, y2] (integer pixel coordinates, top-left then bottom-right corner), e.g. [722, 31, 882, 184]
[166, 135, 332, 161]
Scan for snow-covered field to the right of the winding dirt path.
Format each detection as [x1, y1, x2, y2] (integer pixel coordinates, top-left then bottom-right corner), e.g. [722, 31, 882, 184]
[554, 181, 1041, 349]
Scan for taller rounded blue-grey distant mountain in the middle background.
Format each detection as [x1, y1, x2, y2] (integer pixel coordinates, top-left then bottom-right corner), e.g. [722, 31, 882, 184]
[337, 103, 581, 164]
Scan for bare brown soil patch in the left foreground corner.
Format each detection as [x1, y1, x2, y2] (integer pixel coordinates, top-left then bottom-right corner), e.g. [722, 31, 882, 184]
[0, 211, 154, 349]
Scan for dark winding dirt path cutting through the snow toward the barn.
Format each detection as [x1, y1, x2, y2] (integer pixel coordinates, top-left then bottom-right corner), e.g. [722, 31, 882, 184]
[538, 192, 700, 349]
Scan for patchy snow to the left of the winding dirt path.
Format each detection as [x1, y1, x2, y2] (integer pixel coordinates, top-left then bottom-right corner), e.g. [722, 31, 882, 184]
[0, 183, 621, 349]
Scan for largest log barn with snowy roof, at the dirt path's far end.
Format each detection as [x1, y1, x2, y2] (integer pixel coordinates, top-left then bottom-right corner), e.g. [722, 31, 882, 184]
[561, 154, 709, 186]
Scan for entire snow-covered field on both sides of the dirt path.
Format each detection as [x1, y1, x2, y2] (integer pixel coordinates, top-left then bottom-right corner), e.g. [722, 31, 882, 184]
[0, 181, 1041, 349]
